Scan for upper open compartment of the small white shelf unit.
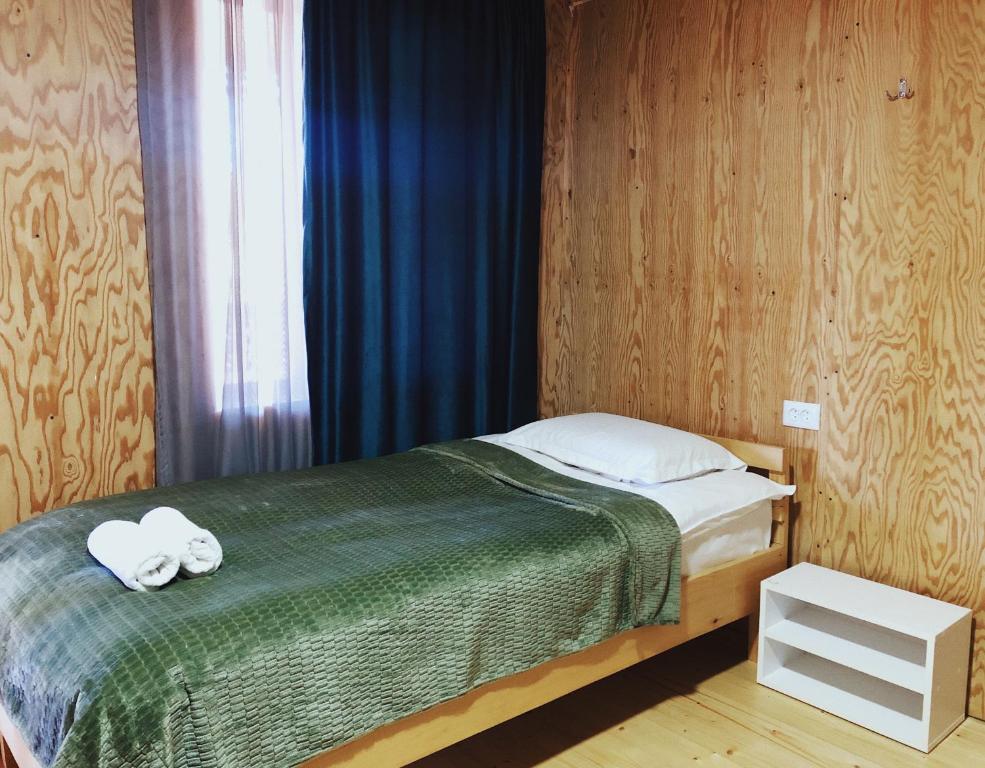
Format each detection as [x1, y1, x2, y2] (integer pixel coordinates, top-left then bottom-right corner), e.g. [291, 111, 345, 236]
[765, 596, 929, 694]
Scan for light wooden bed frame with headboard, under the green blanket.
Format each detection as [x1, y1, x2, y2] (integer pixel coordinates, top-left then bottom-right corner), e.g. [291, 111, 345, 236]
[0, 436, 789, 768]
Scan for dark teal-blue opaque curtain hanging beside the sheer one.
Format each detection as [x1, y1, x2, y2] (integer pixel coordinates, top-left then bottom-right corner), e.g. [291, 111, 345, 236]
[304, 0, 545, 463]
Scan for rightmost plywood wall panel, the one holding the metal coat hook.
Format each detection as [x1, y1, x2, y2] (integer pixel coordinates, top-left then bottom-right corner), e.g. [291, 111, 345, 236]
[815, 2, 985, 717]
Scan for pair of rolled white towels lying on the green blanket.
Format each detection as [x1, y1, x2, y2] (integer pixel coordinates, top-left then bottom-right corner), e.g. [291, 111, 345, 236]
[87, 507, 222, 592]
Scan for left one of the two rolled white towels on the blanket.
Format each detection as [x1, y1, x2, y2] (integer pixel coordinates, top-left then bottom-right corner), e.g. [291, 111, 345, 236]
[86, 520, 180, 592]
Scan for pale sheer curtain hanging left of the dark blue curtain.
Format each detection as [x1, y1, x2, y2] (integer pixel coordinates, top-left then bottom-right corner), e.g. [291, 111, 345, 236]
[134, 0, 310, 483]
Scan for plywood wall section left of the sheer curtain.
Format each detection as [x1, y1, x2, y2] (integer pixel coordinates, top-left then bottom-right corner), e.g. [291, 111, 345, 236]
[0, 0, 154, 530]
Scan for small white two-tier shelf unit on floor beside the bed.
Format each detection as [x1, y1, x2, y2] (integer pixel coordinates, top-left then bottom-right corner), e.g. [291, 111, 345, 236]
[757, 563, 971, 752]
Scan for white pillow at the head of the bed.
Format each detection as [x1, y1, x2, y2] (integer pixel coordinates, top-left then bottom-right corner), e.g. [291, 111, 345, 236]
[498, 413, 746, 483]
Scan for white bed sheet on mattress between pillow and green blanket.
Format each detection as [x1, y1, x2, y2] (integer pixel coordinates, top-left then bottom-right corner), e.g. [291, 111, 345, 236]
[476, 435, 773, 576]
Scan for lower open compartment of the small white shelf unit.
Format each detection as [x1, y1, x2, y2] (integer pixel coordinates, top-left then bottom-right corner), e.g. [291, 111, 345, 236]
[761, 638, 924, 746]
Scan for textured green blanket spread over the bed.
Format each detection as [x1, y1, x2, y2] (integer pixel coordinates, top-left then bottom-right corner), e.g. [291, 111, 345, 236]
[0, 441, 680, 768]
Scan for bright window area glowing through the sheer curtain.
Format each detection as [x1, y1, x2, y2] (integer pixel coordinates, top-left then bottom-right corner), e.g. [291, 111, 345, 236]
[196, 0, 307, 416]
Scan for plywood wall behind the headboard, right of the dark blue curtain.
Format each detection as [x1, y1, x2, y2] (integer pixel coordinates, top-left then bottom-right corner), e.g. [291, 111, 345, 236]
[540, 0, 985, 717]
